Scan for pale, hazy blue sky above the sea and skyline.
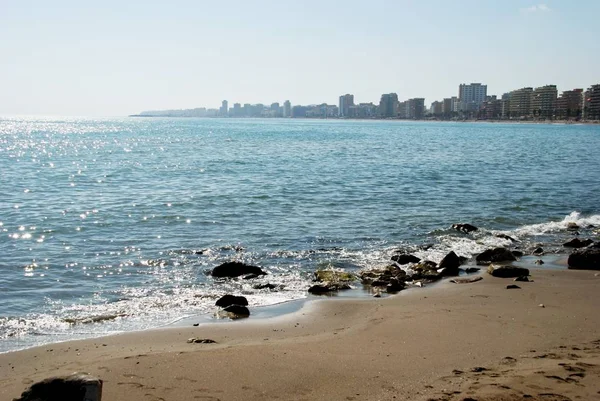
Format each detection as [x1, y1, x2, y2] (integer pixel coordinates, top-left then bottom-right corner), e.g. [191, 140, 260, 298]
[0, 0, 600, 116]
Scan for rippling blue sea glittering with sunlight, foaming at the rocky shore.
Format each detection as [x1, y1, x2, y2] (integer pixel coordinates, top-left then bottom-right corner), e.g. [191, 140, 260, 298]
[0, 117, 600, 352]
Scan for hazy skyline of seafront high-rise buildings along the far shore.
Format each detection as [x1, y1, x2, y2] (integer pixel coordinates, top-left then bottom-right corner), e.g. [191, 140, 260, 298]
[136, 83, 600, 121]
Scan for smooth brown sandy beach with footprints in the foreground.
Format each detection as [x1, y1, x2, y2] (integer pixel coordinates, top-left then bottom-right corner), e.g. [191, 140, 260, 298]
[0, 269, 600, 401]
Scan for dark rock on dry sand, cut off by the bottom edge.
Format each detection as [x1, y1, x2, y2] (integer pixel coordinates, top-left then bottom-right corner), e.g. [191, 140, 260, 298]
[13, 373, 102, 401]
